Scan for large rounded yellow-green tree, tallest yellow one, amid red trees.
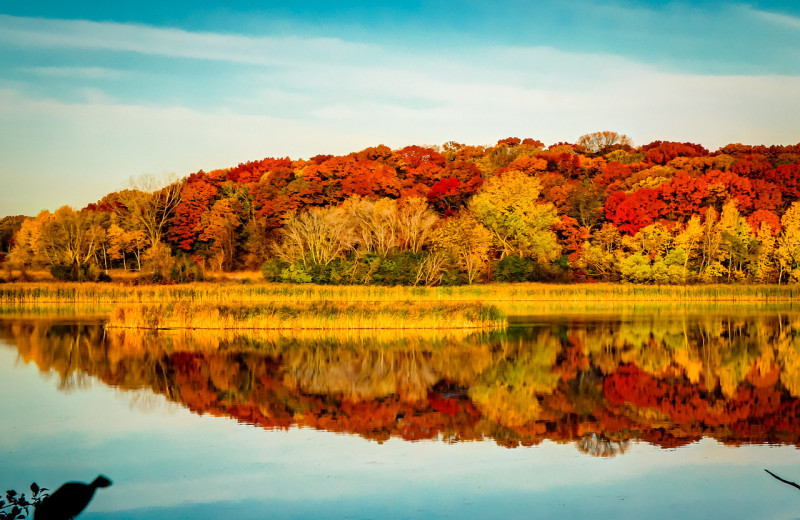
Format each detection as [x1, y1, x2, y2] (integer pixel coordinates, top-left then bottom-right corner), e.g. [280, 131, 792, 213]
[469, 170, 561, 262]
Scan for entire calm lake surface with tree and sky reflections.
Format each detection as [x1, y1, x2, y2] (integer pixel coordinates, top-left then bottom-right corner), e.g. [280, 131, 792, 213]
[0, 307, 800, 519]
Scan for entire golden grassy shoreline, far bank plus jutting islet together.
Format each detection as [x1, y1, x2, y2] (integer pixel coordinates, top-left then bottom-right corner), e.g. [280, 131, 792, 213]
[0, 282, 800, 331]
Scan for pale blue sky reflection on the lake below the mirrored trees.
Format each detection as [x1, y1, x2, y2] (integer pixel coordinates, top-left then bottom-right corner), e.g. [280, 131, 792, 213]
[0, 347, 800, 519]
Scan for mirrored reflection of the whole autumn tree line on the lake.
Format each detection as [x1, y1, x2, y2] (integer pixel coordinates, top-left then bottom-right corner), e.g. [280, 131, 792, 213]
[0, 313, 800, 457]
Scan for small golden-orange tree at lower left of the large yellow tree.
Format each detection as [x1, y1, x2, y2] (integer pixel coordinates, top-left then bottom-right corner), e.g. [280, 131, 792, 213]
[432, 213, 492, 283]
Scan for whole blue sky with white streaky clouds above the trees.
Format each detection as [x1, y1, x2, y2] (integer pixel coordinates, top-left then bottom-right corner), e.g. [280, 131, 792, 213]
[0, 0, 800, 217]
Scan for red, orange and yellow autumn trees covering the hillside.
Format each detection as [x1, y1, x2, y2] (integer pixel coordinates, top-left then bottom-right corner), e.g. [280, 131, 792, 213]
[0, 132, 800, 285]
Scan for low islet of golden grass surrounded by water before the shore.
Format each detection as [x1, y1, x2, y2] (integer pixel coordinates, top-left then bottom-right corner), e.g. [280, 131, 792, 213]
[107, 302, 506, 330]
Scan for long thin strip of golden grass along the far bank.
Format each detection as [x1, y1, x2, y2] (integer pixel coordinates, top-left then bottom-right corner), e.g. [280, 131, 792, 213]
[0, 279, 800, 304]
